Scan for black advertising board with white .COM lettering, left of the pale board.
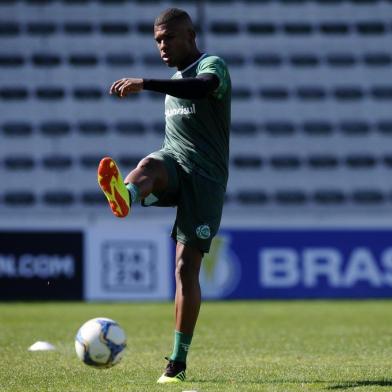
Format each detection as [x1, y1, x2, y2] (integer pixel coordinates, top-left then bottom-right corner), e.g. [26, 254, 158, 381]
[0, 230, 83, 300]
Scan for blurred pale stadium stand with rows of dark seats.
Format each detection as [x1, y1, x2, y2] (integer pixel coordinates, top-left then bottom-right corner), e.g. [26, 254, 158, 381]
[0, 0, 392, 214]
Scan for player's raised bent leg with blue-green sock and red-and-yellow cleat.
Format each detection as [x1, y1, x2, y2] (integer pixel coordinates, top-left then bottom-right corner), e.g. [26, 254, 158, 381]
[98, 157, 168, 218]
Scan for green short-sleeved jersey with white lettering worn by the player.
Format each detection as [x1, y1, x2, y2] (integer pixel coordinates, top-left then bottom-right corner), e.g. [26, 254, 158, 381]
[163, 54, 231, 188]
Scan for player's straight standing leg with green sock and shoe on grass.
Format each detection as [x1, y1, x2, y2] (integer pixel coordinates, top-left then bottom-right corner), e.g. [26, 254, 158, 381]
[158, 242, 203, 384]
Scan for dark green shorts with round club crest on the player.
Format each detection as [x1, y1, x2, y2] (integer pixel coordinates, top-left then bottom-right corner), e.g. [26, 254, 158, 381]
[142, 150, 225, 253]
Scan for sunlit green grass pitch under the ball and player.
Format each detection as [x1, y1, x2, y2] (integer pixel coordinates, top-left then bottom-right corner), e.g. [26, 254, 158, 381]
[0, 301, 392, 392]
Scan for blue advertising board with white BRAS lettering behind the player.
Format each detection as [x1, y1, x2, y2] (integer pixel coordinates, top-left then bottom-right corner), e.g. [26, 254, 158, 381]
[201, 228, 392, 298]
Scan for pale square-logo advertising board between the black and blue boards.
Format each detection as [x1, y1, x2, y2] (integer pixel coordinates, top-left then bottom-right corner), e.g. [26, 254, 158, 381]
[85, 221, 173, 301]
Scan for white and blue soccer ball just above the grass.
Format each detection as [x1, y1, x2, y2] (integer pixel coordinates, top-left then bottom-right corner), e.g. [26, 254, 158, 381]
[75, 317, 127, 368]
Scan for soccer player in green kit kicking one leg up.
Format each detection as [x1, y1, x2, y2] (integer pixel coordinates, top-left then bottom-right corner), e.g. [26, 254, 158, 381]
[98, 8, 231, 384]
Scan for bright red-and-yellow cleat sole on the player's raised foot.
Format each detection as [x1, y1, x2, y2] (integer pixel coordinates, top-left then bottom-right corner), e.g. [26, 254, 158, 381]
[98, 157, 131, 218]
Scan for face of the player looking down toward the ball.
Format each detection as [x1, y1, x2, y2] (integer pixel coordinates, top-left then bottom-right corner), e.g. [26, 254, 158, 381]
[154, 24, 195, 69]
